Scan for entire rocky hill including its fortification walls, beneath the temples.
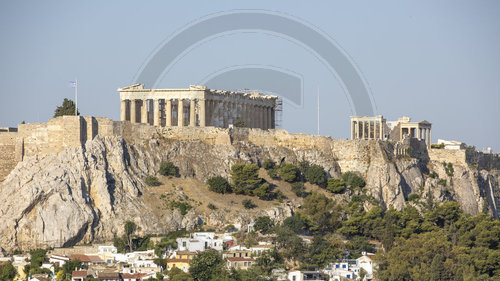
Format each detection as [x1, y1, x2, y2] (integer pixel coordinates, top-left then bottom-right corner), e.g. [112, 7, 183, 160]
[0, 86, 500, 251]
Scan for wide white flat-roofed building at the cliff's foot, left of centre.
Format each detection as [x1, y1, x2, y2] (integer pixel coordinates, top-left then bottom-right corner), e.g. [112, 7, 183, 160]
[176, 232, 224, 252]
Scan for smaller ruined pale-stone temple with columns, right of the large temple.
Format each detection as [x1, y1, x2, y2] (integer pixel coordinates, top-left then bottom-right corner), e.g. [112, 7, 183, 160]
[351, 115, 432, 148]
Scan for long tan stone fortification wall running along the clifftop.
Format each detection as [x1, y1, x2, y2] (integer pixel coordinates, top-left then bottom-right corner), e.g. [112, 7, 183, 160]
[0, 116, 500, 181]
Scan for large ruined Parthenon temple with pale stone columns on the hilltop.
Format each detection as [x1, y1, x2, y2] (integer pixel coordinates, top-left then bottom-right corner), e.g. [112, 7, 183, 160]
[118, 84, 278, 129]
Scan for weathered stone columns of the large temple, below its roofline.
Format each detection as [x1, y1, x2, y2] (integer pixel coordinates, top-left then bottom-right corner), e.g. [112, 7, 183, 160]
[120, 99, 275, 129]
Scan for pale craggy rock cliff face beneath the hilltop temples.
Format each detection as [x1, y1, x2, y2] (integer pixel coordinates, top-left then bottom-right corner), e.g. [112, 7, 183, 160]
[0, 129, 500, 251]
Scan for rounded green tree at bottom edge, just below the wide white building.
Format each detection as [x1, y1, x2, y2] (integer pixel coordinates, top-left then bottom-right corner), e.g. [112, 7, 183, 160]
[189, 249, 224, 281]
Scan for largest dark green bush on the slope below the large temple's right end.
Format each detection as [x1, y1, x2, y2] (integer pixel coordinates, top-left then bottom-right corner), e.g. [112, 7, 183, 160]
[231, 163, 262, 195]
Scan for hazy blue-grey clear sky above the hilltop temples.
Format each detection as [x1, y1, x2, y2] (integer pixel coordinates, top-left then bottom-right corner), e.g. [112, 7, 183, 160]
[0, 0, 500, 152]
